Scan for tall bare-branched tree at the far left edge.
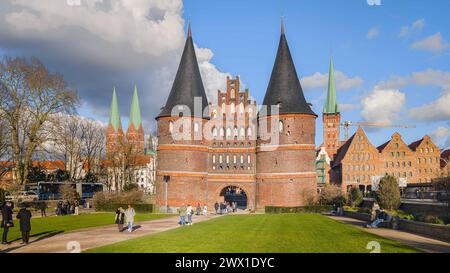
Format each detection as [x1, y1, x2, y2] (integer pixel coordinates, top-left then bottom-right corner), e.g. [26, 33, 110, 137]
[0, 57, 78, 185]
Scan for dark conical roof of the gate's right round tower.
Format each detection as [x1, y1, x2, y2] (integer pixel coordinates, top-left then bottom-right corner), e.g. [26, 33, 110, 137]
[263, 23, 317, 116]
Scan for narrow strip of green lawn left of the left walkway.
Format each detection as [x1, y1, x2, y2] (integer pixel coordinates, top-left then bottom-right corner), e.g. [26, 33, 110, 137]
[8, 212, 173, 241]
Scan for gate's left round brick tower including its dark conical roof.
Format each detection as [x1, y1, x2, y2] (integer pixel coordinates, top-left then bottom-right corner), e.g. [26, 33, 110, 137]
[156, 23, 209, 209]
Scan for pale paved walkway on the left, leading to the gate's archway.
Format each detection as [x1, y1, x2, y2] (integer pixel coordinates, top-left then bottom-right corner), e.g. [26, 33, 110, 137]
[0, 212, 218, 253]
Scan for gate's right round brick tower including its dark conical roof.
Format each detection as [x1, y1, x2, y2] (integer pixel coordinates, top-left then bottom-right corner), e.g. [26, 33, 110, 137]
[256, 19, 317, 208]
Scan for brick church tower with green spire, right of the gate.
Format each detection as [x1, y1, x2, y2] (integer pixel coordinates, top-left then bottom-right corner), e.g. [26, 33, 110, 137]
[322, 58, 341, 160]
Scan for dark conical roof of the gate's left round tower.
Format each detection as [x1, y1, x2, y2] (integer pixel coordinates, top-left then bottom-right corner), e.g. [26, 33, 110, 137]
[157, 24, 208, 118]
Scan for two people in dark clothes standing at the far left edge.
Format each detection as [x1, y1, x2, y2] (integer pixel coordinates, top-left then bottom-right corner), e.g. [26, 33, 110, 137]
[1, 202, 32, 245]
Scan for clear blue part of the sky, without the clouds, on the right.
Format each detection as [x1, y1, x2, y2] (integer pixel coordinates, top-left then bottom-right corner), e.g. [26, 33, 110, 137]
[184, 0, 450, 148]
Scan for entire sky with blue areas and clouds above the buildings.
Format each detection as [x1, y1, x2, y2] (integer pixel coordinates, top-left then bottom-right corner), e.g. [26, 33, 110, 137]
[0, 0, 450, 147]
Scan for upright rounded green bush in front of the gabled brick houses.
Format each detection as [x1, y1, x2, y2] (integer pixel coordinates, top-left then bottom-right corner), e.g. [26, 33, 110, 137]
[376, 175, 401, 210]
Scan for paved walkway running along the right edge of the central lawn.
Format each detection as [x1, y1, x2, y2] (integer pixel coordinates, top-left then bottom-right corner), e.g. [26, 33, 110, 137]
[328, 216, 450, 253]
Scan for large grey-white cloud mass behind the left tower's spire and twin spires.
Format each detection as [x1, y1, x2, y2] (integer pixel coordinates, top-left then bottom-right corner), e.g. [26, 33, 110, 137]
[0, 0, 229, 126]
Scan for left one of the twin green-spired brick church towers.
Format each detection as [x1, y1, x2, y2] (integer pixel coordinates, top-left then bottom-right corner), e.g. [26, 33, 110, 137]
[106, 88, 124, 156]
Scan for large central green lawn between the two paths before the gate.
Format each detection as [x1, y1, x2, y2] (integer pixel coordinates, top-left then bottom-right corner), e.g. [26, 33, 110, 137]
[87, 213, 418, 253]
